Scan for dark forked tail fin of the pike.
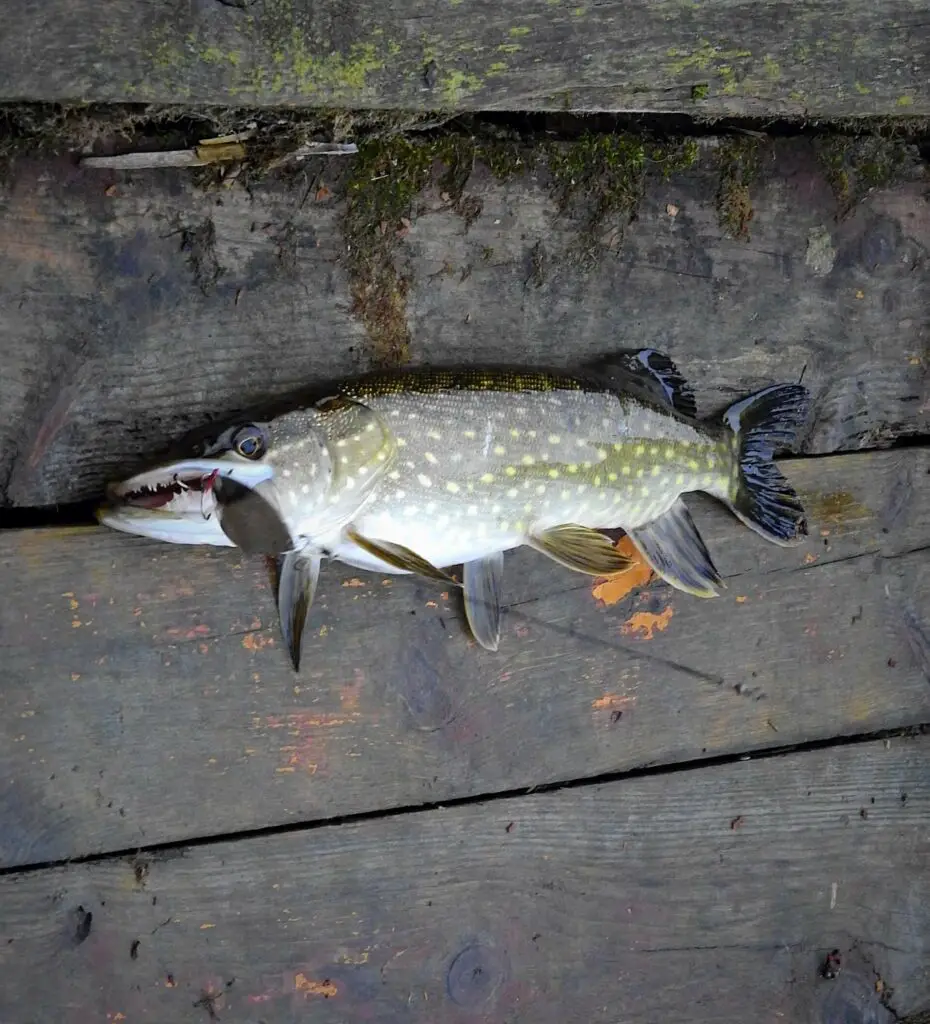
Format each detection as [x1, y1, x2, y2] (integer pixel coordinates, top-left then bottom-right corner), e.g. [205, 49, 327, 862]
[723, 384, 810, 545]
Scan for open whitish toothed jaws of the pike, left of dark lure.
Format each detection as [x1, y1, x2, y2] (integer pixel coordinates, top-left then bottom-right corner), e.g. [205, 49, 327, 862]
[96, 458, 273, 547]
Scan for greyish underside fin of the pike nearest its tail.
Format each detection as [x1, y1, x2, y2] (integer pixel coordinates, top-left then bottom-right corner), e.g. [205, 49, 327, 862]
[629, 498, 723, 597]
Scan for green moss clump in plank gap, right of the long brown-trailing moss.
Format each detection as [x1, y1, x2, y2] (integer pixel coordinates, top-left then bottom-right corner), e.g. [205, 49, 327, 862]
[547, 133, 698, 264]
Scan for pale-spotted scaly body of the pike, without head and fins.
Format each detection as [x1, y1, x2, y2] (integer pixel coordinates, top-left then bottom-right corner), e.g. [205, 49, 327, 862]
[334, 375, 734, 567]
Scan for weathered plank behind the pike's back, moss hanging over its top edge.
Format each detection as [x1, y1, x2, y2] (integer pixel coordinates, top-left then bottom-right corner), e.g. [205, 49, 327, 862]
[0, 134, 930, 506]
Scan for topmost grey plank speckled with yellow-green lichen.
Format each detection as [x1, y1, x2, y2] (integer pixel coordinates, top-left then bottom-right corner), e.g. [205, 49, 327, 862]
[0, 0, 930, 119]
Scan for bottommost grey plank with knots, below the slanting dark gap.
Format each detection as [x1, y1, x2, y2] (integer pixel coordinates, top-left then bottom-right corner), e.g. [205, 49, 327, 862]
[0, 736, 930, 1024]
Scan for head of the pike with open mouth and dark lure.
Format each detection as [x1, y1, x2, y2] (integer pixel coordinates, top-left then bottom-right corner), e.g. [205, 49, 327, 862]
[97, 409, 333, 555]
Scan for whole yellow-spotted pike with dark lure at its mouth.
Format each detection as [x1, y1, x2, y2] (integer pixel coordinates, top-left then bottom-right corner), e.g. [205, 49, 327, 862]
[97, 349, 809, 670]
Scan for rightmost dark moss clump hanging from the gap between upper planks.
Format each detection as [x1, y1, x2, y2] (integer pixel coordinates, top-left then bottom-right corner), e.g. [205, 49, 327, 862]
[814, 135, 918, 216]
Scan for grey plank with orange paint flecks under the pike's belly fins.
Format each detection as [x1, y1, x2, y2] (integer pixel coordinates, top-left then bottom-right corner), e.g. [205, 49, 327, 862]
[0, 449, 930, 865]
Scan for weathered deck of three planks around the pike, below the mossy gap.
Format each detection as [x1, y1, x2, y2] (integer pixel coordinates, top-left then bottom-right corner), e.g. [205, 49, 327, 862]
[0, 101, 930, 1024]
